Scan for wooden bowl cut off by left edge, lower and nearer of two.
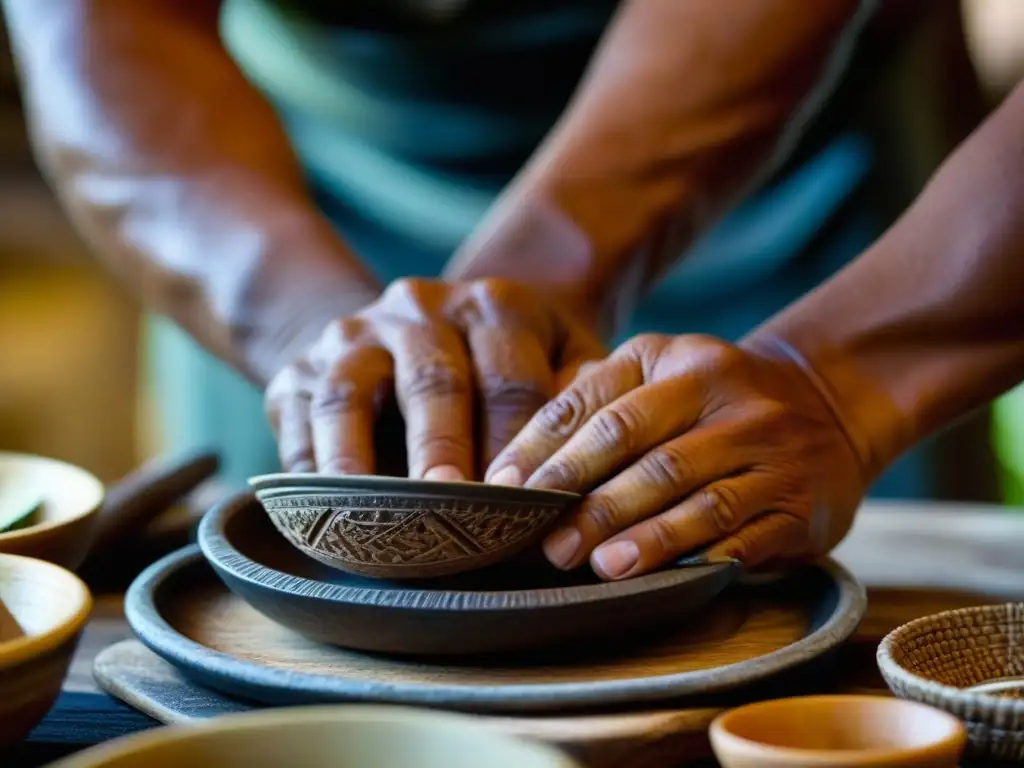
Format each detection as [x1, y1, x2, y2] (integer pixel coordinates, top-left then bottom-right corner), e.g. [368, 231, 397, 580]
[0, 555, 92, 746]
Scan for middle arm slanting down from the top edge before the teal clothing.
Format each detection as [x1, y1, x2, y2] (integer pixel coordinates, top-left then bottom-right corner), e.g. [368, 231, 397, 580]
[447, 0, 873, 335]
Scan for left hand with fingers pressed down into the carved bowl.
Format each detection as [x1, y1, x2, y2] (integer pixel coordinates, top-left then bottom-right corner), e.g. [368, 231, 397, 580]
[266, 280, 603, 480]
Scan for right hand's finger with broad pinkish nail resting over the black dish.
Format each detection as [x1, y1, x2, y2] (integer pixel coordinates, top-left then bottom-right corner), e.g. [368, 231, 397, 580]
[590, 472, 776, 580]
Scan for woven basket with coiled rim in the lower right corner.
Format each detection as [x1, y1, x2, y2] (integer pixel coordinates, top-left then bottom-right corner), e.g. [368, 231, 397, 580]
[878, 603, 1024, 763]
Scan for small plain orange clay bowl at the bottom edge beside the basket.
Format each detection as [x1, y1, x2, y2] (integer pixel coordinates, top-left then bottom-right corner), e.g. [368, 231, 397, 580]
[710, 695, 966, 768]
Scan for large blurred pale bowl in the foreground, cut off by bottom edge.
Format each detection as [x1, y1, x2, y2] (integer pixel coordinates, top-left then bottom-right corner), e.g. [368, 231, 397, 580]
[44, 706, 580, 768]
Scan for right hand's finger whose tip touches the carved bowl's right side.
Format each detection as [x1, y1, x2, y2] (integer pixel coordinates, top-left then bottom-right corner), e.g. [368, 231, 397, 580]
[542, 415, 761, 569]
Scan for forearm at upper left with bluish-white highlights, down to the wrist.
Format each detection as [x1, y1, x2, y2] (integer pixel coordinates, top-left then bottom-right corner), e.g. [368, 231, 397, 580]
[4, 0, 376, 384]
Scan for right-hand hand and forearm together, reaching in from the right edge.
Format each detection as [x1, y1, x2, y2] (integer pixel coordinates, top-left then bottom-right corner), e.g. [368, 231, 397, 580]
[487, 76, 1024, 579]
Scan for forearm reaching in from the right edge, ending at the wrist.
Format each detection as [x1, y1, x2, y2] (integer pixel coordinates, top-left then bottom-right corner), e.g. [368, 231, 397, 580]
[746, 76, 1024, 474]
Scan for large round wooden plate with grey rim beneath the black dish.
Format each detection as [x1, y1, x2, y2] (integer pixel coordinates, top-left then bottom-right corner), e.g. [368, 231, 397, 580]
[125, 548, 866, 712]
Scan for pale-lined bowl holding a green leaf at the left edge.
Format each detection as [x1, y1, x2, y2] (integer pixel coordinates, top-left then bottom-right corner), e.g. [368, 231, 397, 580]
[0, 453, 104, 570]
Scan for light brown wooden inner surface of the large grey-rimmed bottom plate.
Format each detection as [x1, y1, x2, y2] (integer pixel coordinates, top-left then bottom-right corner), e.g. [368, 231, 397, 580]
[166, 584, 811, 685]
